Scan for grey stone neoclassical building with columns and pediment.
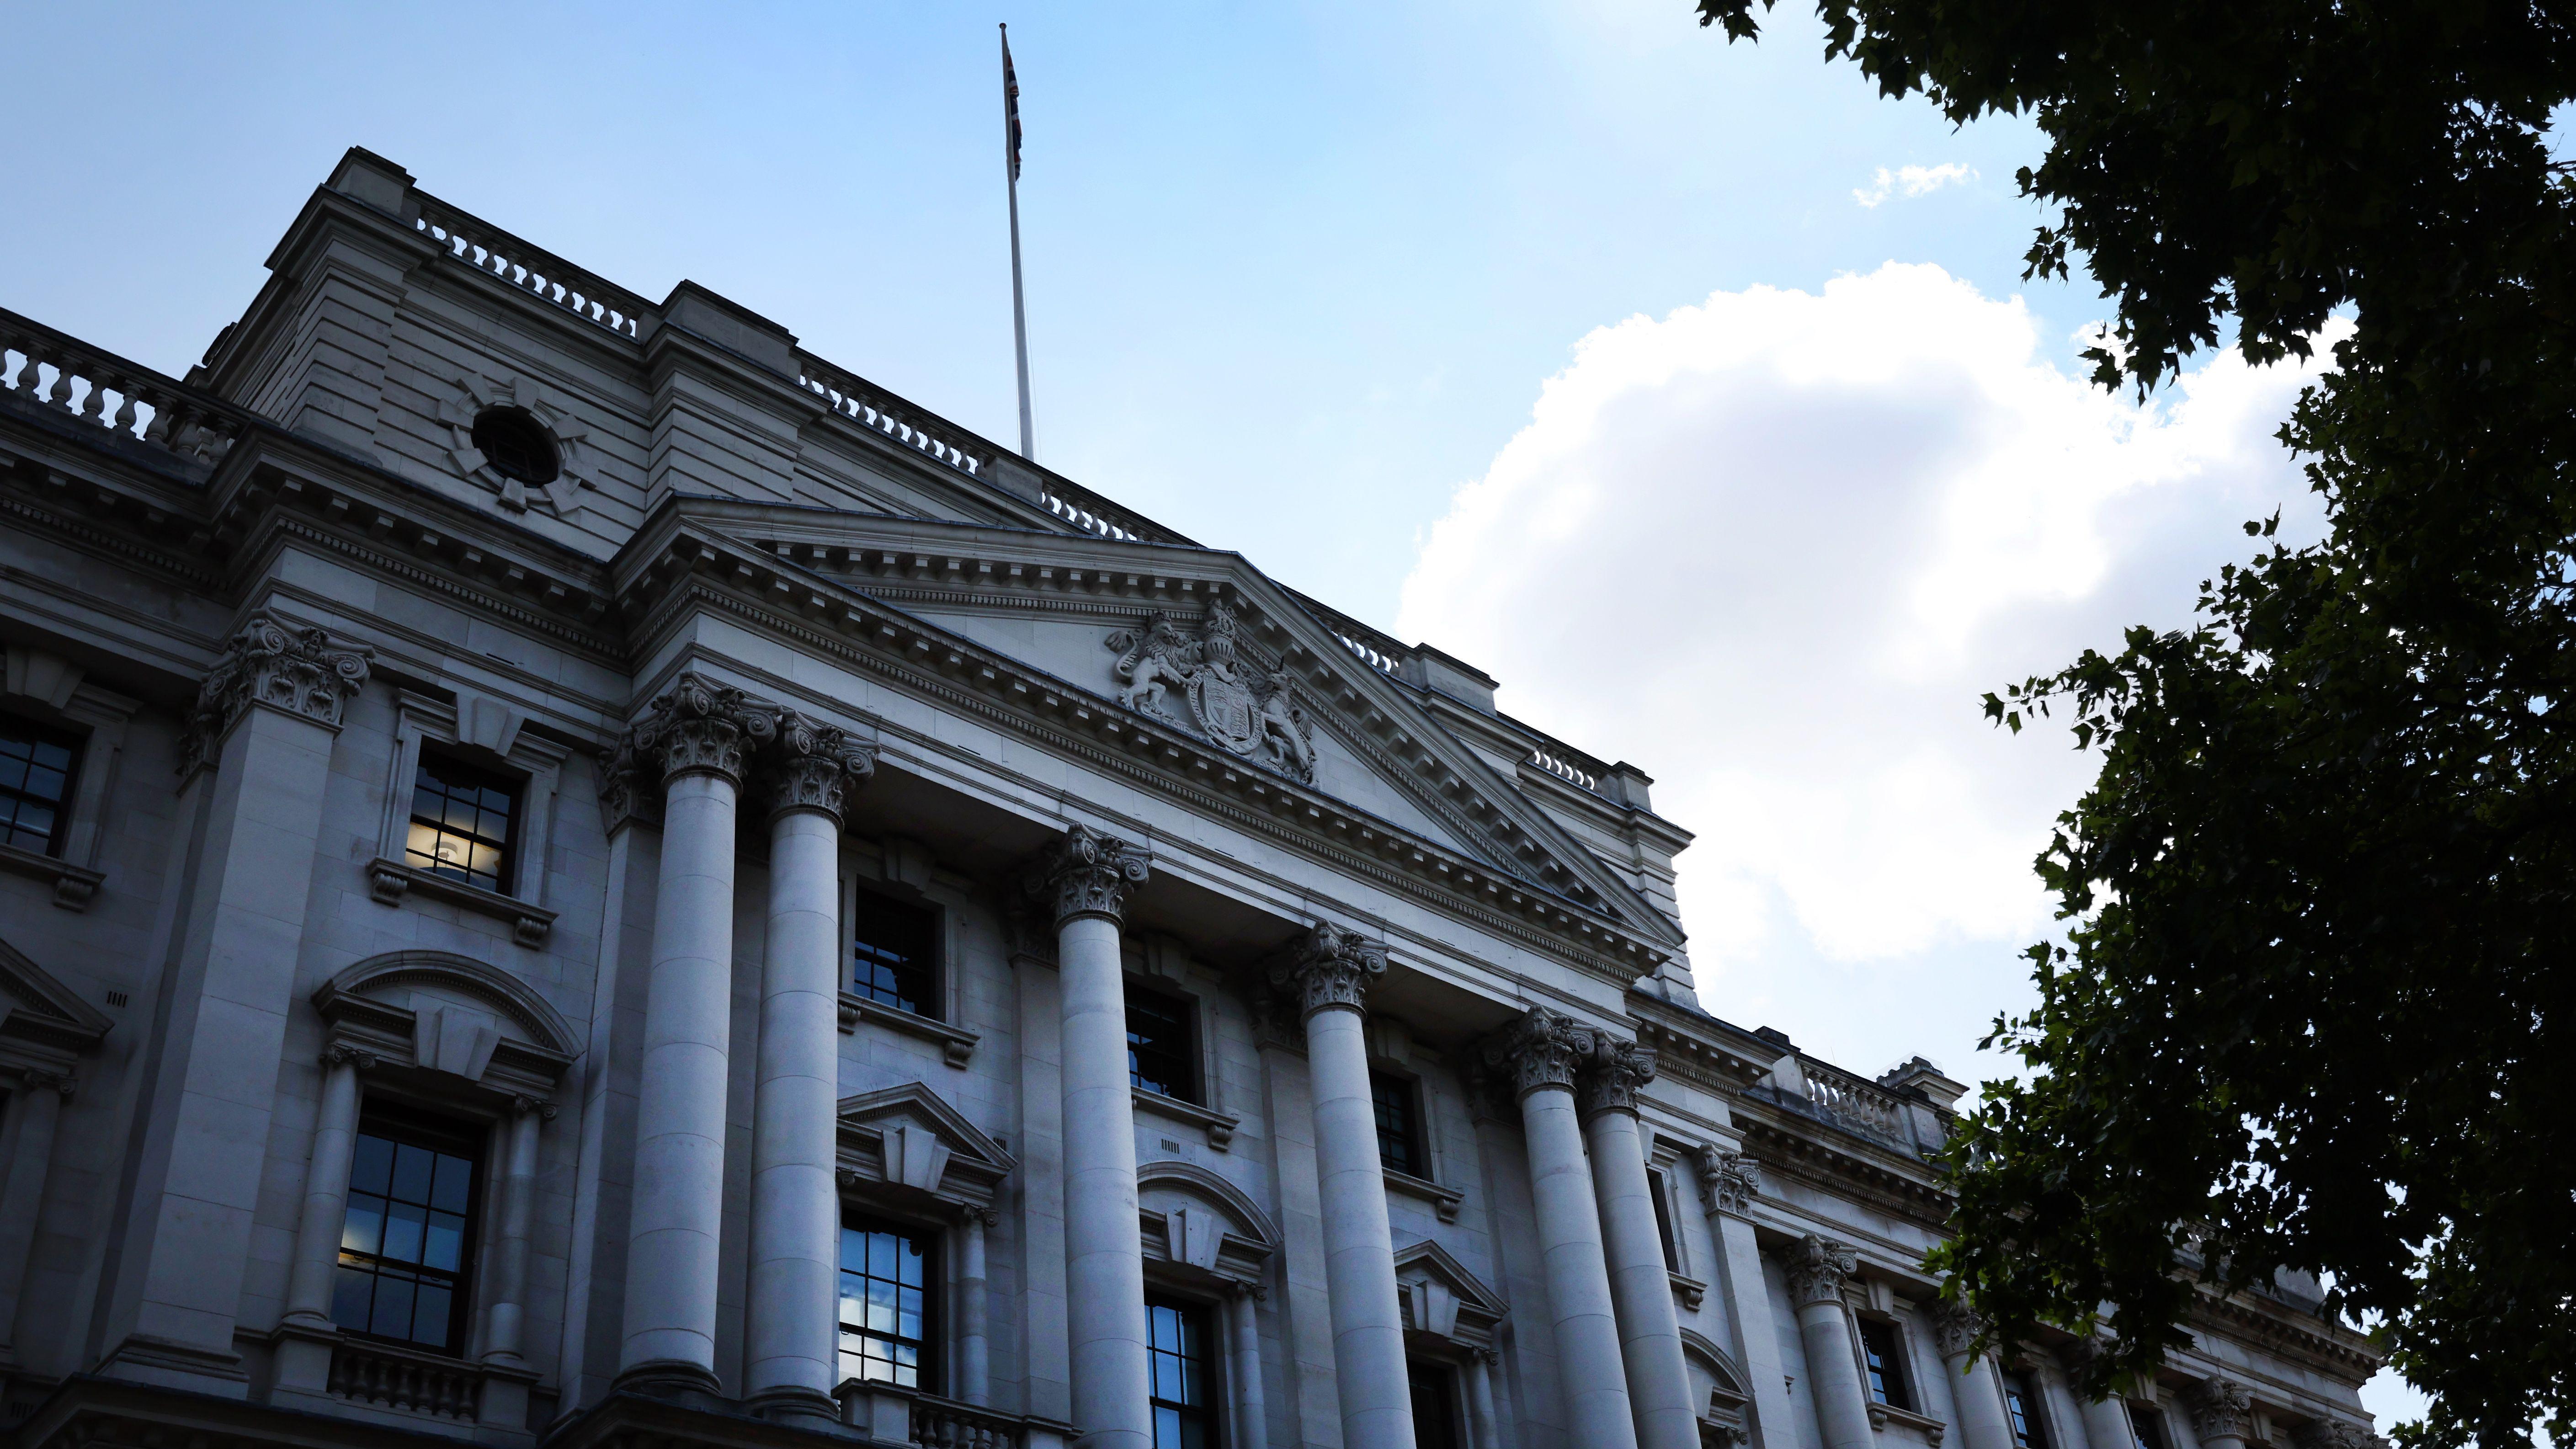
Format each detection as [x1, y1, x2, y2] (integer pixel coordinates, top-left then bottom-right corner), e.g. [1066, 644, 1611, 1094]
[0, 152, 2375, 1449]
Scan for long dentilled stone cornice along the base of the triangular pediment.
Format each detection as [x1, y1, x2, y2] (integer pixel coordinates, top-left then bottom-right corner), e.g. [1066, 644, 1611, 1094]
[628, 577, 1664, 985]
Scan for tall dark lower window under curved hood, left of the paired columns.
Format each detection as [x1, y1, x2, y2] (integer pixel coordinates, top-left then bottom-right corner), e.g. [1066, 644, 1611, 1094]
[330, 1116, 477, 1353]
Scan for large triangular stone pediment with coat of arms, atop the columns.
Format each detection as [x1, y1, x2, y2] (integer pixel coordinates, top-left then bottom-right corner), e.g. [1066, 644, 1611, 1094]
[659, 500, 1682, 972]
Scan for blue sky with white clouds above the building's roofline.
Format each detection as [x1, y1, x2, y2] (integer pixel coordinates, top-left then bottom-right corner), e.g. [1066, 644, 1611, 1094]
[0, 0, 2411, 1413]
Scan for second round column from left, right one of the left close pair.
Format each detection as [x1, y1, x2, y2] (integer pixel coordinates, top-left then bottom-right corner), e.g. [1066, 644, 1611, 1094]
[742, 714, 876, 1428]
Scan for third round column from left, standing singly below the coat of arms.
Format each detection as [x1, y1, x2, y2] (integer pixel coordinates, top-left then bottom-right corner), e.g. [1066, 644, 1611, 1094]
[1025, 825, 1154, 1449]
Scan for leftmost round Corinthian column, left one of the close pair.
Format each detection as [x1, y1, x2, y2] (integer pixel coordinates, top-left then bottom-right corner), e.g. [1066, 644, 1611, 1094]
[618, 673, 775, 1392]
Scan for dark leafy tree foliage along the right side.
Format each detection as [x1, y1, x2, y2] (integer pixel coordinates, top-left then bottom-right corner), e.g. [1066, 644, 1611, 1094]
[1700, 0, 2576, 1449]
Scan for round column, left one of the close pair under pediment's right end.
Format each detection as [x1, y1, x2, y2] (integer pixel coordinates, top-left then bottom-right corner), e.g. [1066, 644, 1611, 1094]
[1484, 1006, 1638, 1449]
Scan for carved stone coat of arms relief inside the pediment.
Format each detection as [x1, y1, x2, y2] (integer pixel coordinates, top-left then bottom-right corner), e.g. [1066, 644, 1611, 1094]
[1107, 598, 1314, 784]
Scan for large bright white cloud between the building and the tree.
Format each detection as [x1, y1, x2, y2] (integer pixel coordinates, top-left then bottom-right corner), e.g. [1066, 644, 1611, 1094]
[1399, 263, 2349, 1070]
